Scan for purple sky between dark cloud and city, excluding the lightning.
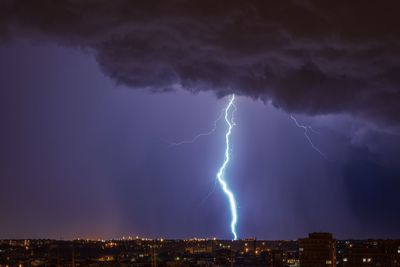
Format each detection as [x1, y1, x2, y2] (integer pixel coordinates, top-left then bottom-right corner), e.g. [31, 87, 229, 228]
[0, 41, 400, 239]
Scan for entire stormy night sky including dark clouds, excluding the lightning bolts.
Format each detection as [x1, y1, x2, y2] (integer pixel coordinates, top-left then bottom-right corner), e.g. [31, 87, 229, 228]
[0, 0, 400, 239]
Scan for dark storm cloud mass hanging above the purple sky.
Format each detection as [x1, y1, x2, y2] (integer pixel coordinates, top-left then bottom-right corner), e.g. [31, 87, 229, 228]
[0, 0, 400, 124]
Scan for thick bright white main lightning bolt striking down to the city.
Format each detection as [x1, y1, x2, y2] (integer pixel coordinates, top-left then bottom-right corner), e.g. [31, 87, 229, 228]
[217, 94, 238, 240]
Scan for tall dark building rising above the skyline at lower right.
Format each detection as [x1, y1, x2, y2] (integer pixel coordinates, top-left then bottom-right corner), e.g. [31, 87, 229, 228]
[299, 233, 336, 267]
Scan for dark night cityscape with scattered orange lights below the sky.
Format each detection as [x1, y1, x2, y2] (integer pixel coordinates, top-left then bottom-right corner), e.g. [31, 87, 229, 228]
[0, 233, 400, 267]
